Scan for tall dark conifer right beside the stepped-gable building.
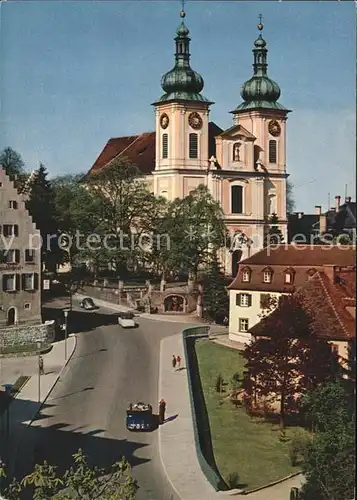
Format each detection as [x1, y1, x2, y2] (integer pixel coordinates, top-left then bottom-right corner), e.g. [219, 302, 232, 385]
[26, 163, 64, 272]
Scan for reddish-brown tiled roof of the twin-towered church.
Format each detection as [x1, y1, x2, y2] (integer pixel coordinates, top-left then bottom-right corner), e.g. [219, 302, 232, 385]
[87, 122, 222, 175]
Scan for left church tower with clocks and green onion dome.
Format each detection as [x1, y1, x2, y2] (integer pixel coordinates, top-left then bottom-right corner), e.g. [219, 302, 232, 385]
[153, 10, 213, 200]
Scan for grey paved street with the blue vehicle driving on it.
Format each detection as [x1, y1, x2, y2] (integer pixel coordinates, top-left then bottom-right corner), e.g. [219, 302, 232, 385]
[12, 296, 195, 500]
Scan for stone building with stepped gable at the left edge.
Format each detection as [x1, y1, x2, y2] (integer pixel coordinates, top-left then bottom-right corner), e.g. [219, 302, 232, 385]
[0, 168, 41, 328]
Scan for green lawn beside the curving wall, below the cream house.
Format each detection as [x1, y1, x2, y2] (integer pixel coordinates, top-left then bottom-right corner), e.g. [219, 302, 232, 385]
[196, 340, 299, 490]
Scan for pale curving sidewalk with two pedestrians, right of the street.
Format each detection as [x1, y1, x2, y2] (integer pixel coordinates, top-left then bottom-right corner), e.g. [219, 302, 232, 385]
[159, 334, 302, 500]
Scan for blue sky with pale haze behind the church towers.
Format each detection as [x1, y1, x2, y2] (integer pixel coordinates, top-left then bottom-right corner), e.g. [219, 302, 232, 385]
[0, 0, 356, 212]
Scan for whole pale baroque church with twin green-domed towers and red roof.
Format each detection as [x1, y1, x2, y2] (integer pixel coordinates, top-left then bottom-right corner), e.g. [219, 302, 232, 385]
[88, 11, 290, 276]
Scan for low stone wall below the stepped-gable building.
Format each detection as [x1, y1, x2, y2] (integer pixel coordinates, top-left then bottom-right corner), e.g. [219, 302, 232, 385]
[0, 320, 55, 347]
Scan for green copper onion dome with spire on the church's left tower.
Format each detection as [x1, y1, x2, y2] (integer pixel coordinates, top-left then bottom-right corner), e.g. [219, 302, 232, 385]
[155, 12, 212, 104]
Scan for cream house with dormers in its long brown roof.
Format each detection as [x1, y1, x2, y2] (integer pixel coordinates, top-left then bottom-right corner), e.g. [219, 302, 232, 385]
[228, 244, 356, 343]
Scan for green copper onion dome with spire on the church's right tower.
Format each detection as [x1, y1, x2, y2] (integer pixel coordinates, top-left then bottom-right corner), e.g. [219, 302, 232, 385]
[233, 28, 288, 113]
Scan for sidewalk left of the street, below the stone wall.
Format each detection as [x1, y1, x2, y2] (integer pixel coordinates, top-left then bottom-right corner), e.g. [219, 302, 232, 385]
[1, 335, 77, 476]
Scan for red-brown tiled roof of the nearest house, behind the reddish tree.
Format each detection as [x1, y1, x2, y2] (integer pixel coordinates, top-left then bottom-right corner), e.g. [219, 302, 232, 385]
[249, 272, 356, 341]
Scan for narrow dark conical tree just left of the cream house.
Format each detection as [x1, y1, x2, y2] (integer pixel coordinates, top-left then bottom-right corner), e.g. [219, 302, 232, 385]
[203, 255, 229, 322]
